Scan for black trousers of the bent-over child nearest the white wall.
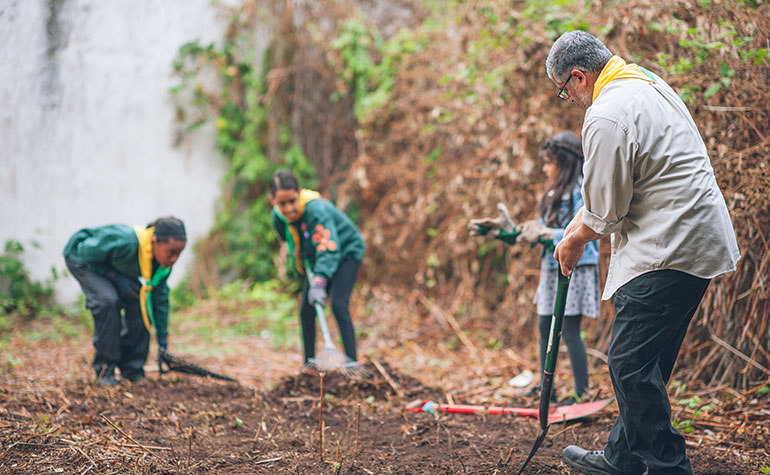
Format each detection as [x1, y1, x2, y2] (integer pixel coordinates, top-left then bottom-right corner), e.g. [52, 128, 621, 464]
[65, 258, 150, 380]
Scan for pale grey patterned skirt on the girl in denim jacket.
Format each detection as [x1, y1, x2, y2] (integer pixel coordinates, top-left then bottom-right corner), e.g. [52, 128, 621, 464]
[534, 259, 599, 318]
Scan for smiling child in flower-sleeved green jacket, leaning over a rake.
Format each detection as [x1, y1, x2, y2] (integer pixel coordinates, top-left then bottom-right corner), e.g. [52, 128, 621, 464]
[270, 170, 366, 364]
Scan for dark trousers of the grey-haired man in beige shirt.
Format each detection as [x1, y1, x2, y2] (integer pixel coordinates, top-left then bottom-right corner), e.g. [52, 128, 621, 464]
[605, 269, 709, 475]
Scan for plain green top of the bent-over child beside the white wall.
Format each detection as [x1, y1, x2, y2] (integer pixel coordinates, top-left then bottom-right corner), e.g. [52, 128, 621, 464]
[64, 224, 168, 339]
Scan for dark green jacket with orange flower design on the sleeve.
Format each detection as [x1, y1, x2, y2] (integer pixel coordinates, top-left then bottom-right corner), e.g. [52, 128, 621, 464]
[272, 198, 366, 280]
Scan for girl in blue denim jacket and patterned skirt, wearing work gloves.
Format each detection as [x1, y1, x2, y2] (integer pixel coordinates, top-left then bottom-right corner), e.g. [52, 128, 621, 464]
[520, 132, 599, 405]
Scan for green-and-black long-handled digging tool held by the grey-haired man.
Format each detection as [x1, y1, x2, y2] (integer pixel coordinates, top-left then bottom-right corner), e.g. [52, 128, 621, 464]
[517, 269, 569, 475]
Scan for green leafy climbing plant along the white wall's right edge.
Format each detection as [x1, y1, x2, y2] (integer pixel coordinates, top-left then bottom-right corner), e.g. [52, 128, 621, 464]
[171, 12, 316, 300]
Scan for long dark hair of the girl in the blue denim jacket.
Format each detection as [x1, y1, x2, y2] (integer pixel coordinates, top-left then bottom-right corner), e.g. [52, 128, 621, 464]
[537, 131, 583, 227]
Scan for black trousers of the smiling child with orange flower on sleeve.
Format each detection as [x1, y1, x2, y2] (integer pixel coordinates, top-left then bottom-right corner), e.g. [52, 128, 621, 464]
[299, 258, 361, 363]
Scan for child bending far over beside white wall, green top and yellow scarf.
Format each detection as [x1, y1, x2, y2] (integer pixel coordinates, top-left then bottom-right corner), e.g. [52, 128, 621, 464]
[64, 217, 187, 386]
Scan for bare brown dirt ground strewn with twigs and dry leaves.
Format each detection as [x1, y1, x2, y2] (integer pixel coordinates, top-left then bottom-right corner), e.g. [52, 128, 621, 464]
[0, 312, 770, 475]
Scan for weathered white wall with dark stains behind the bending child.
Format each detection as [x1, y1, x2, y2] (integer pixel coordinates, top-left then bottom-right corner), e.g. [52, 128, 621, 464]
[0, 0, 248, 303]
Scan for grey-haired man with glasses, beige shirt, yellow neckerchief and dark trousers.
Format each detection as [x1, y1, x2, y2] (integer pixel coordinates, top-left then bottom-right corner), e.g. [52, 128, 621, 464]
[546, 31, 740, 475]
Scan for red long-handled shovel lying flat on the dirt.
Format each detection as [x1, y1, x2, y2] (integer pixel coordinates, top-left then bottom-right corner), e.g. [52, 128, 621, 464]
[406, 398, 613, 424]
